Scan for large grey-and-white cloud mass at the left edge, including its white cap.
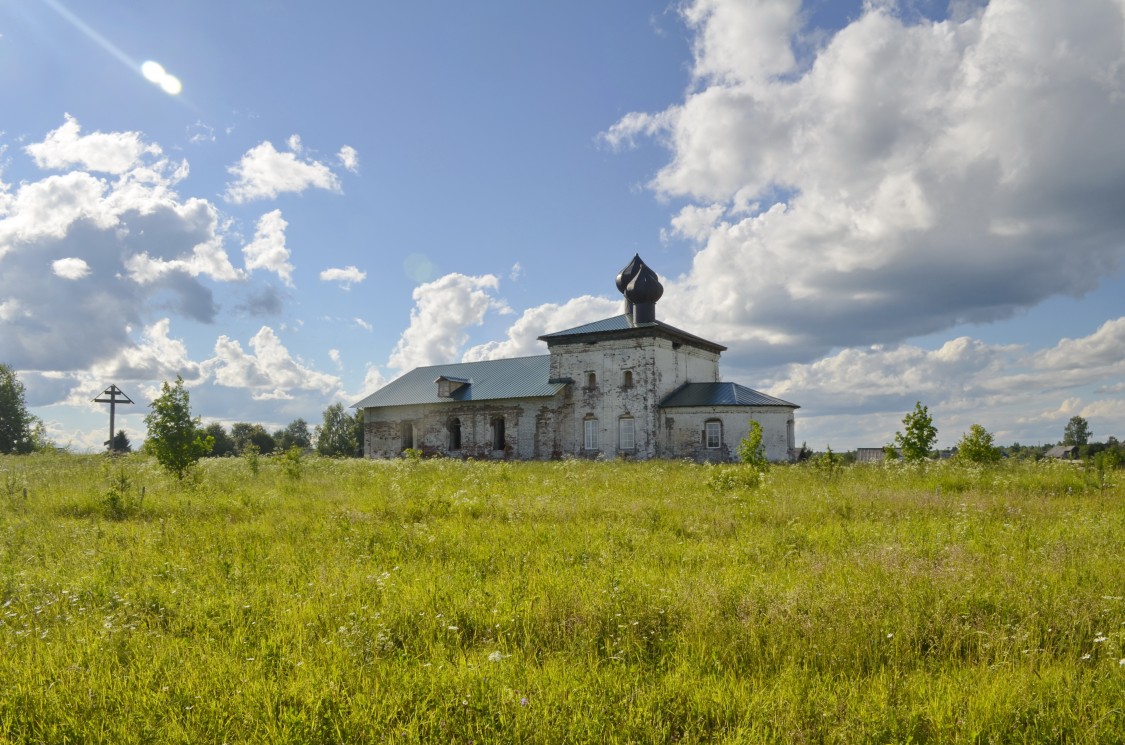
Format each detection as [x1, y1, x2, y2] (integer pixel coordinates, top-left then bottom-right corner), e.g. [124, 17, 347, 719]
[0, 117, 242, 371]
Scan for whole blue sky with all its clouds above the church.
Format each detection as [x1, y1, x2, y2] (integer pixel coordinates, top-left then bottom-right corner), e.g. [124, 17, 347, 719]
[0, 0, 1125, 451]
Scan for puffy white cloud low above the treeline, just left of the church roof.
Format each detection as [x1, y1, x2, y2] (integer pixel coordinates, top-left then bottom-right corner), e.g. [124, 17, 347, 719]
[204, 326, 342, 401]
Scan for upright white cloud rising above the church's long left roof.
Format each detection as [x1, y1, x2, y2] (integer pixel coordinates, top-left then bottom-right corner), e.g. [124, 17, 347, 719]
[387, 273, 510, 373]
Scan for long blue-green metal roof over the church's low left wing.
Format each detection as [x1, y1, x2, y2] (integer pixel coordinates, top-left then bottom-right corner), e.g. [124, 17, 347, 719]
[353, 354, 566, 409]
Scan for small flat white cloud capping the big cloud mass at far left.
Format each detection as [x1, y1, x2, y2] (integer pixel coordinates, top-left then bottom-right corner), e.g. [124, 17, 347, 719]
[25, 114, 161, 174]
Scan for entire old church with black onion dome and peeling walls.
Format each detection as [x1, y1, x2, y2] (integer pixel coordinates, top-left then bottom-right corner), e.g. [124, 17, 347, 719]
[356, 255, 799, 461]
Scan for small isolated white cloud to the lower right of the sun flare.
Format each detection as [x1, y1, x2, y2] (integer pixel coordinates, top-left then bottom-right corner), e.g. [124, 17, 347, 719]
[225, 140, 340, 204]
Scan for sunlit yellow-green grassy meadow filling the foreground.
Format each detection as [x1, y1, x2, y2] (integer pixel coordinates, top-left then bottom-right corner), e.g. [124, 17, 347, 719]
[0, 454, 1125, 743]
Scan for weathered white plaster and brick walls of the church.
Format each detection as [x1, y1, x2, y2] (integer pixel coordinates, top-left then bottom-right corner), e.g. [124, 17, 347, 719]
[365, 336, 794, 460]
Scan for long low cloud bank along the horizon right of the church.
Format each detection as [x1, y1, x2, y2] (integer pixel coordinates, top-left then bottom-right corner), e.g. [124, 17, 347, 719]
[756, 317, 1125, 449]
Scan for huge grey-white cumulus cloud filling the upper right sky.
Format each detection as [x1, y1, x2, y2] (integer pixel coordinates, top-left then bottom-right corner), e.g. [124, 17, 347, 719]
[603, 0, 1125, 365]
